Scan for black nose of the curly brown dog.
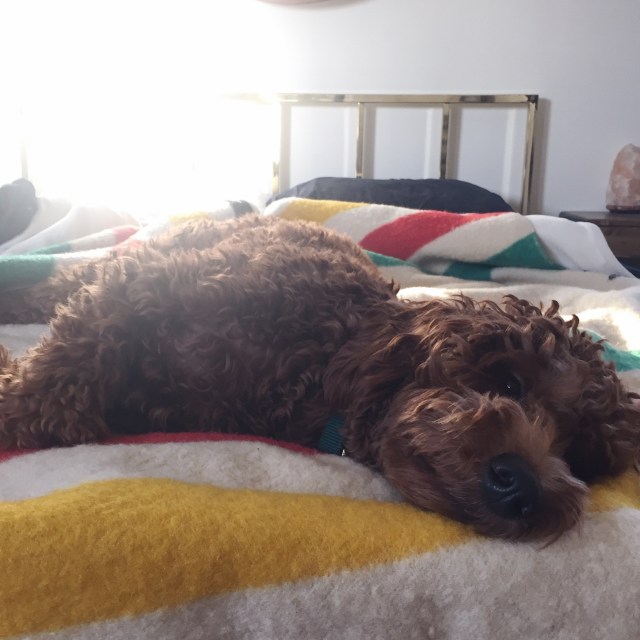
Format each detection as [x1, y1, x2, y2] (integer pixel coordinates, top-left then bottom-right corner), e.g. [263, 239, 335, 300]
[483, 453, 540, 520]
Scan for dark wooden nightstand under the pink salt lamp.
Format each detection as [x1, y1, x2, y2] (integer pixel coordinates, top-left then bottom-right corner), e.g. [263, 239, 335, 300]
[560, 211, 640, 266]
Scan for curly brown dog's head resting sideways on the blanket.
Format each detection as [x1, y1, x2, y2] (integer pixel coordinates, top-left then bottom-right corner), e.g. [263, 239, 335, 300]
[350, 296, 640, 540]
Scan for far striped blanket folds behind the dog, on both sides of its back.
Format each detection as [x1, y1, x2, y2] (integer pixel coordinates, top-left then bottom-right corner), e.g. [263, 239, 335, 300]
[0, 198, 631, 290]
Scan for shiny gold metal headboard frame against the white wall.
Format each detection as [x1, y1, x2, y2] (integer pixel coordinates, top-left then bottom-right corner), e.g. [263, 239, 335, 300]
[225, 93, 538, 214]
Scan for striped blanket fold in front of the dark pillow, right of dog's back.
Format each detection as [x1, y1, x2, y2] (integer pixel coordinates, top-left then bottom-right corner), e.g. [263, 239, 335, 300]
[265, 198, 631, 282]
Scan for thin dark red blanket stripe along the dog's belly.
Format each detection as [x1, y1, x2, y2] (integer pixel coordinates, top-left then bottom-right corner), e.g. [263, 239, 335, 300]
[0, 431, 320, 462]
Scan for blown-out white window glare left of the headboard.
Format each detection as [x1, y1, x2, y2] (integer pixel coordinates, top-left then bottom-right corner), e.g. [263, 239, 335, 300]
[0, 0, 286, 215]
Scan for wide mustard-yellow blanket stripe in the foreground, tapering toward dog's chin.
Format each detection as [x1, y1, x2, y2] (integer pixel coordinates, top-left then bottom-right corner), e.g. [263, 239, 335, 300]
[0, 479, 473, 637]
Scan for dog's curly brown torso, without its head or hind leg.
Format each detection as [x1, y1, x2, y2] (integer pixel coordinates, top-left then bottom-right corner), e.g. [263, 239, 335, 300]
[0, 216, 396, 444]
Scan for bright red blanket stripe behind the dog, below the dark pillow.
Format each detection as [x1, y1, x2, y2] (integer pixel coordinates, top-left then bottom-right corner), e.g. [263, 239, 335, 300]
[360, 211, 504, 260]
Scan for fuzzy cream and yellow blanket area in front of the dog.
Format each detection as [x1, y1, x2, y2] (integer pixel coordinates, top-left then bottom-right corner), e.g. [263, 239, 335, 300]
[0, 435, 640, 640]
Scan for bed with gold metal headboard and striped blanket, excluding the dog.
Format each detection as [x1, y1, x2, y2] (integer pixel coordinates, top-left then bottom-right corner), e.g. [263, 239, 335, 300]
[0, 94, 640, 640]
